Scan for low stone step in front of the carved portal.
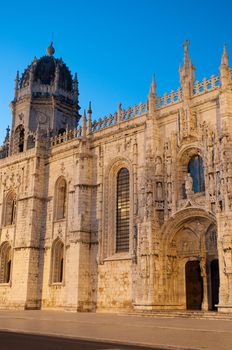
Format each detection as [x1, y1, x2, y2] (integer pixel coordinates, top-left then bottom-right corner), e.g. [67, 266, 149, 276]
[124, 310, 232, 321]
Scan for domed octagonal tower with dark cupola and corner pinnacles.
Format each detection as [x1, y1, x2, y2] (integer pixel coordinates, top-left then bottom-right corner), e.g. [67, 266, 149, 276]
[10, 42, 80, 154]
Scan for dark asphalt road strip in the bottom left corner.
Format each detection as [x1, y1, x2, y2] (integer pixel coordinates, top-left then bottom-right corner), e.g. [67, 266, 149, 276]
[0, 332, 161, 350]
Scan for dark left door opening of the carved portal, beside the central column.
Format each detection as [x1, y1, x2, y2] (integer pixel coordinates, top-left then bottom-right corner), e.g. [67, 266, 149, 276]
[185, 261, 203, 310]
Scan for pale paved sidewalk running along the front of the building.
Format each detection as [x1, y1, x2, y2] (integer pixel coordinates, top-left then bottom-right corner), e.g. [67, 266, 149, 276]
[0, 310, 232, 350]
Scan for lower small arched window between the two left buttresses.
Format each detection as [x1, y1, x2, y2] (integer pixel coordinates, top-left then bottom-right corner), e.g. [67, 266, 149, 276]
[51, 239, 64, 283]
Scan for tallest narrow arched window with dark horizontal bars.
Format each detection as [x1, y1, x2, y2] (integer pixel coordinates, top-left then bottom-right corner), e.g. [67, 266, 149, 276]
[116, 168, 130, 252]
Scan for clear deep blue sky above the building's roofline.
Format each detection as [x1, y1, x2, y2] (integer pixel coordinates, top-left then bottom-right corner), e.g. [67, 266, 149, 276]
[0, 0, 232, 142]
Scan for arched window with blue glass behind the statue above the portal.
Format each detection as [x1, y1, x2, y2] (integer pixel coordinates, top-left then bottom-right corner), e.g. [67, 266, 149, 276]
[188, 155, 205, 193]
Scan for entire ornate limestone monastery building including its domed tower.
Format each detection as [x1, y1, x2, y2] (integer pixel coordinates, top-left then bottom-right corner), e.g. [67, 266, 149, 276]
[0, 42, 232, 313]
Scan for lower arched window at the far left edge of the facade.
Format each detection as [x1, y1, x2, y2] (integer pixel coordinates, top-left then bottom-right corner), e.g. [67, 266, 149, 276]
[0, 242, 12, 283]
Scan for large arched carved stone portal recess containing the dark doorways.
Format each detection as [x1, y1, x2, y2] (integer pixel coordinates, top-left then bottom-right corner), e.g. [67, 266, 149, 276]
[165, 217, 219, 310]
